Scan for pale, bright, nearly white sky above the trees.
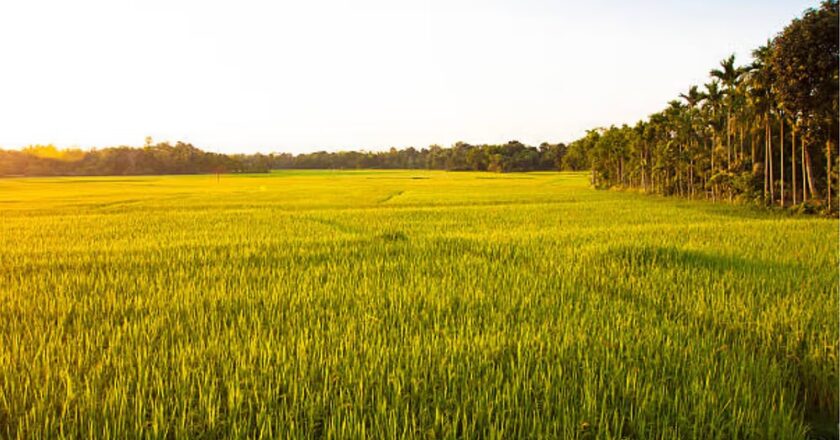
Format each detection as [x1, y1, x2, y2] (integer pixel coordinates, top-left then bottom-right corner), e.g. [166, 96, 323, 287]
[0, 0, 818, 153]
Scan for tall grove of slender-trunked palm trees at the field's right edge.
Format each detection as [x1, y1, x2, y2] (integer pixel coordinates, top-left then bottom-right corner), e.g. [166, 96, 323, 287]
[569, 0, 840, 210]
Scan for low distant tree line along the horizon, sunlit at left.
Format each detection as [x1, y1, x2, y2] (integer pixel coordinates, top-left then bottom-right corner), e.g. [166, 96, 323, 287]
[0, 140, 588, 176]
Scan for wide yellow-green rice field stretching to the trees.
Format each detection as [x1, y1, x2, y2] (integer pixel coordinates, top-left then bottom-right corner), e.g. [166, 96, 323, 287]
[0, 171, 838, 438]
